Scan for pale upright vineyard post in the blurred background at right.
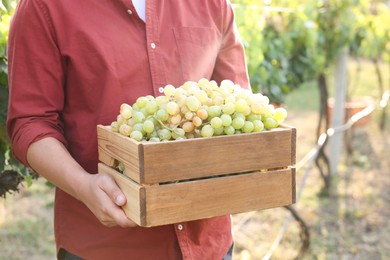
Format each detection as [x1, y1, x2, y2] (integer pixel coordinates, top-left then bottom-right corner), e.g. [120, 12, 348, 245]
[329, 48, 348, 175]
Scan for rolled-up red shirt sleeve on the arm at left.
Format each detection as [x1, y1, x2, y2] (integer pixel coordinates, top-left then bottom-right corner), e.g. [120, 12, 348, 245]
[7, 0, 66, 166]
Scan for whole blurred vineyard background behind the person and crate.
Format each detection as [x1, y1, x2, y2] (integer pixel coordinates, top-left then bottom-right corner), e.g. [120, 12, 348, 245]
[0, 0, 390, 260]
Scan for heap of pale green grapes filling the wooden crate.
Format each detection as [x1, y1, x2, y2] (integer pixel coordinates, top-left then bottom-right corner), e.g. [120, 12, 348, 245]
[111, 78, 287, 142]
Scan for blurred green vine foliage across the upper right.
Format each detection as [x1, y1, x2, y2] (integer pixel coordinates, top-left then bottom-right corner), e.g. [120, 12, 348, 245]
[233, 0, 390, 103]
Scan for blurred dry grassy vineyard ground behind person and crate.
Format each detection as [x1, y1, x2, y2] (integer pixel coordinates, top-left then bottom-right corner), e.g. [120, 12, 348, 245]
[0, 106, 390, 260]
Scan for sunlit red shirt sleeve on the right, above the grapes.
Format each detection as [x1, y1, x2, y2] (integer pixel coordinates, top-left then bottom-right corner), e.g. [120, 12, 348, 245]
[212, 0, 250, 89]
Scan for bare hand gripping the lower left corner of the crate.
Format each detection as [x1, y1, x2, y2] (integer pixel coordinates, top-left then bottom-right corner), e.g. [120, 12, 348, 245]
[78, 173, 137, 227]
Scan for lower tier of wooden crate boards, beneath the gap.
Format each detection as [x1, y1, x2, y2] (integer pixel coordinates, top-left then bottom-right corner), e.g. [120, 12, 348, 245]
[99, 164, 295, 226]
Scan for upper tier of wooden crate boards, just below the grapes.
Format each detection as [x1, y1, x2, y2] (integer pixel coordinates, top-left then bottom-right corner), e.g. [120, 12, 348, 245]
[98, 126, 296, 184]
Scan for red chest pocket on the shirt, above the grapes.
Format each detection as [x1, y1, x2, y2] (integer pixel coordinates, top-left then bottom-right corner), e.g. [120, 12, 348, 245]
[173, 27, 221, 81]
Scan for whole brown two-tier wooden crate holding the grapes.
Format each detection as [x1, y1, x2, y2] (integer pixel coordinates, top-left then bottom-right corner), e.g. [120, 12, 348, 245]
[98, 125, 296, 226]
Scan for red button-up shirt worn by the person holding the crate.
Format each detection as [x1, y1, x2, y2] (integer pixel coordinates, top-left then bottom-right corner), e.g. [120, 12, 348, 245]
[7, 0, 249, 260]
